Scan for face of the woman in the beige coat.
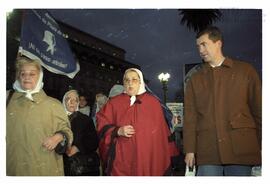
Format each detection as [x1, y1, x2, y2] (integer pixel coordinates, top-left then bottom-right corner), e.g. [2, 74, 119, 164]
[19, 64, 40, 90]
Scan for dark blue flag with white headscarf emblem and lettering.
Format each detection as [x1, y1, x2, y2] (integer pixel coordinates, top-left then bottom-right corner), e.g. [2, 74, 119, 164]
[19, 9, 80, 78]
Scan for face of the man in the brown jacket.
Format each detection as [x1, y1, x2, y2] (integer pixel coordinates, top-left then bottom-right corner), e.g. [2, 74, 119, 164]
[196, 34, 221, 63]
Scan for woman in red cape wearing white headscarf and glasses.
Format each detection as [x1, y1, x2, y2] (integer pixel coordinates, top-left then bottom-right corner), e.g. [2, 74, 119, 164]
[97, 68, 177, 176]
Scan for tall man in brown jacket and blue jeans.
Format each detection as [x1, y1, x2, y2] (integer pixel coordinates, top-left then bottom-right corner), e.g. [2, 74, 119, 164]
[184, 27, 262, 176]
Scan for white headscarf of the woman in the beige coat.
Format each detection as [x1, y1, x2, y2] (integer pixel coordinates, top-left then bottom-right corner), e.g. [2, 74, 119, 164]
[13, 69, 43, 101]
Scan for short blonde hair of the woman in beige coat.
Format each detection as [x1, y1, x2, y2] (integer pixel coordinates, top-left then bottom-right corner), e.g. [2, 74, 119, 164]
[15, 56, 42, 79]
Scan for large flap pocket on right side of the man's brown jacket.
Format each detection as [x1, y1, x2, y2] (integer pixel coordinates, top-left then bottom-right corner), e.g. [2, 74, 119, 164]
[230, 114, 260, 155]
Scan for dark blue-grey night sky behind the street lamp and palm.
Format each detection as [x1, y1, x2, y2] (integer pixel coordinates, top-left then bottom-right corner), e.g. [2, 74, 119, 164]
[50, 9, 262, 102]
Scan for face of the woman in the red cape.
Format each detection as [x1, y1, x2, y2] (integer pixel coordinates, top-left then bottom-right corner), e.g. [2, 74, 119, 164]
[124, 71, 141, 96]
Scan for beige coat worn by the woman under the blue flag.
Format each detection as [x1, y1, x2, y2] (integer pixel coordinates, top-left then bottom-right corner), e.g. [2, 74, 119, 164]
[6, 90, 73, 176]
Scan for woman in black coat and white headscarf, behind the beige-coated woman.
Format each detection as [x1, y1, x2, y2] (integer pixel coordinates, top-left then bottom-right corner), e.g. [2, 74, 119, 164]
[63, 90, 99, 176]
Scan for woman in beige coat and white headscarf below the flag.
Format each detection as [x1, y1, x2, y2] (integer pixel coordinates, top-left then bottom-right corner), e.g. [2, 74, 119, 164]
[6, 57, 73, 176]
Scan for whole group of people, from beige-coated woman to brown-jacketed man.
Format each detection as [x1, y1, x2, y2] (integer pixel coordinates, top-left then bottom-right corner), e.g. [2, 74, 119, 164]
[6, 27, 262, 176]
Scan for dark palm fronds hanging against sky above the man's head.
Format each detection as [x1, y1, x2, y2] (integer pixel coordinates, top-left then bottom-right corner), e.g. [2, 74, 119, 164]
[179, 9, 222, 32]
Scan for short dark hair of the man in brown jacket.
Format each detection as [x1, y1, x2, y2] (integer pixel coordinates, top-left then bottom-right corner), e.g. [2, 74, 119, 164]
[196, 26, 223, 42]
